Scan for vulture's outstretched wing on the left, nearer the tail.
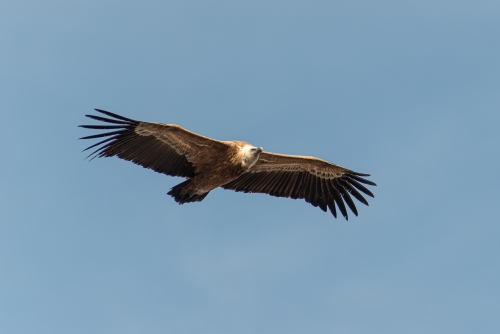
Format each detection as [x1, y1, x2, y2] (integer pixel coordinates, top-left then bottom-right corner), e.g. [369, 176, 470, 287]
[80, 109, 227, 177]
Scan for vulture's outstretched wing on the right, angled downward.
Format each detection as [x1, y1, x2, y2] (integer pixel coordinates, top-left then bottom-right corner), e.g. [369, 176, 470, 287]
[222, 152, 376, 220]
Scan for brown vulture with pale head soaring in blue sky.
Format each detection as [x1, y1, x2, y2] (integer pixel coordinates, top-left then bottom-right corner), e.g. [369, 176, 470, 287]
[80, 109, 376, 220]
